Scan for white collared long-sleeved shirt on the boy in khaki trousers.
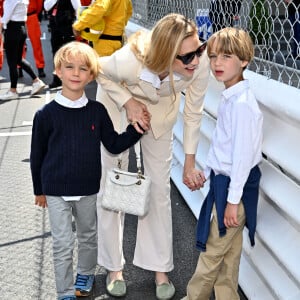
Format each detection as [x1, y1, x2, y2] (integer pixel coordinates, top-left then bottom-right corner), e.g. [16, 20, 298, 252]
[204, 80, 263, 204]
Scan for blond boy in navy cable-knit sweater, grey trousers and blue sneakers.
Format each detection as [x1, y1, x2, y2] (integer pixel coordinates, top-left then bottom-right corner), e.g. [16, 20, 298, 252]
[30, 42, 150, 300]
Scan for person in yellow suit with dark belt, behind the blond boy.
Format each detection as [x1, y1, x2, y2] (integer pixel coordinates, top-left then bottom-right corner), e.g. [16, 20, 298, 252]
[73, 0, 132, 56]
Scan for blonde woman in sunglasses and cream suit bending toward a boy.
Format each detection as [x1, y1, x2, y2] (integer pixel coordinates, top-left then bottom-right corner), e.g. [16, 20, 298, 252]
[97, 14, 209, 299]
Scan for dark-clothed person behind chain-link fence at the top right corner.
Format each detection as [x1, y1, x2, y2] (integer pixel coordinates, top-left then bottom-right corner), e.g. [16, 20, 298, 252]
[285, 0, 300, 59]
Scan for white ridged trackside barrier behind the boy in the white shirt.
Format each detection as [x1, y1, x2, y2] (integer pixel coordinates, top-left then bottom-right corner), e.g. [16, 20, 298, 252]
[172, 71, 300, 300]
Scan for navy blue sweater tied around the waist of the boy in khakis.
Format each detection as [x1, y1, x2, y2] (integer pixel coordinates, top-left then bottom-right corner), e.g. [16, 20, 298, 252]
[196, 166, 261, 251]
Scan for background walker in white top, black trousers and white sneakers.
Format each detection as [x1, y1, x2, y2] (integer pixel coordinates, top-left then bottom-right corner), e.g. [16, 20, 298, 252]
[0, 0, 45, 101]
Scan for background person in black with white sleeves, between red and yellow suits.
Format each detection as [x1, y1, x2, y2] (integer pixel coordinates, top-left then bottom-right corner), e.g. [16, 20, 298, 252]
[44, 0, 80, 89]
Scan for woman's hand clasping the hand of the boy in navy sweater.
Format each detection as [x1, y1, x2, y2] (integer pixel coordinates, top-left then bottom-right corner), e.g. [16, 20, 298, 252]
[124, 98, 151, 133]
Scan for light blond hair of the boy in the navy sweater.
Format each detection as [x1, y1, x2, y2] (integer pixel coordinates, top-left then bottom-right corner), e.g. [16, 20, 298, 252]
[54, 42, 100, 79]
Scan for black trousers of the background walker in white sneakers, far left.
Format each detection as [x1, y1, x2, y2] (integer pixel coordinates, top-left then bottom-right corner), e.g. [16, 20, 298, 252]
[4, 21, 37, 88]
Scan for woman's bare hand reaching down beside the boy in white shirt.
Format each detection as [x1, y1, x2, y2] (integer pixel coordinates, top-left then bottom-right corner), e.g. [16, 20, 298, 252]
[183, 154, 206, 191]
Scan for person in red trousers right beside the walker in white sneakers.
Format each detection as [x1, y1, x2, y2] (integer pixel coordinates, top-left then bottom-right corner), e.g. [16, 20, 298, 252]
[26, 0, 46, 77]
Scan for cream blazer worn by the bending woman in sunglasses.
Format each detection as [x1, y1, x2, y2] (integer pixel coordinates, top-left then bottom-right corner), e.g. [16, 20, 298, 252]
[97, 44, 209, 154]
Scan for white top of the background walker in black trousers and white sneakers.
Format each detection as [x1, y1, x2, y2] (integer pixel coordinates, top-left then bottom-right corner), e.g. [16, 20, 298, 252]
[1, 0, 29, 29]
